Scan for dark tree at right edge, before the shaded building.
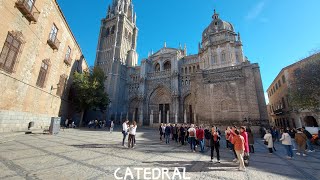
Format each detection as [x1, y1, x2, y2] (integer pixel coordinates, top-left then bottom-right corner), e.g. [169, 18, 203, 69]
[289, 54, 320, 111]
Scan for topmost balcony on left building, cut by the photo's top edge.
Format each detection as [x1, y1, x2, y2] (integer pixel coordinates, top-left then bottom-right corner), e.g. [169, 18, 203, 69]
[15, 0, 40, 23]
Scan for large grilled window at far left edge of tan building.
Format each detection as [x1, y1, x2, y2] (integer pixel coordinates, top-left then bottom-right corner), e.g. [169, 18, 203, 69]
[0, 32, 22, 73]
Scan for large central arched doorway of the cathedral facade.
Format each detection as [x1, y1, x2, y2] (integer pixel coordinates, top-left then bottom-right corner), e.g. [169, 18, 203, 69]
[148, 87, 171, 123]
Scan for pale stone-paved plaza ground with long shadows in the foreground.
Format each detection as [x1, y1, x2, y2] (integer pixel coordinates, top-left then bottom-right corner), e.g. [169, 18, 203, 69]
[0, 126, 320, 180]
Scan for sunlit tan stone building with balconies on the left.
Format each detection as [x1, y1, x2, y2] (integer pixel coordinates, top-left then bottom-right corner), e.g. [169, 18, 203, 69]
[0, 0, 88, 131]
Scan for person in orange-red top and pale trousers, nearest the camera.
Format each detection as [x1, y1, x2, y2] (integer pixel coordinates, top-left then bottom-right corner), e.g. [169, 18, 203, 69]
[232, 130, 246, 171]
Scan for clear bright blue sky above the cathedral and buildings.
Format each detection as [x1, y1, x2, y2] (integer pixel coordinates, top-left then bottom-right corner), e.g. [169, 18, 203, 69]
[58, 0, 320, 101]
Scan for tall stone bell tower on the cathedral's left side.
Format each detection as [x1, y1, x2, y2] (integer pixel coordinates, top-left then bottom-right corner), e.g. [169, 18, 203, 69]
[95, 0, 138, 121]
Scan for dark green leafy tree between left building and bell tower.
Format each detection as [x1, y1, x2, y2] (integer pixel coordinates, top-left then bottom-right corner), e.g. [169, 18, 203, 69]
[72, 67, 110, 126]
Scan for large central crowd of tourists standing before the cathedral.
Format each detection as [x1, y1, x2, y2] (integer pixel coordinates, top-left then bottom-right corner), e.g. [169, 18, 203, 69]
[159, 124, 254, 171]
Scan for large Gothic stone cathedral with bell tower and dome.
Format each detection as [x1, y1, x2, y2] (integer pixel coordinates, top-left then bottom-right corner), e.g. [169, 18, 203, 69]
[95, 0, 268, 126]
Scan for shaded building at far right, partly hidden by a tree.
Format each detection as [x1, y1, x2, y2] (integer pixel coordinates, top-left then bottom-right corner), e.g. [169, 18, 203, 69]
[267, 53, 320, 128]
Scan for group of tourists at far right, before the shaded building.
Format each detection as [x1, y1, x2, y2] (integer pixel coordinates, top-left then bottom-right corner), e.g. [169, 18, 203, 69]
[264, 127, 315, 159]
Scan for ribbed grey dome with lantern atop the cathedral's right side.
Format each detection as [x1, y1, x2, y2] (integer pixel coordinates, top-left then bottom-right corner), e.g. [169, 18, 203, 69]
[202, 11, 234, 39]
